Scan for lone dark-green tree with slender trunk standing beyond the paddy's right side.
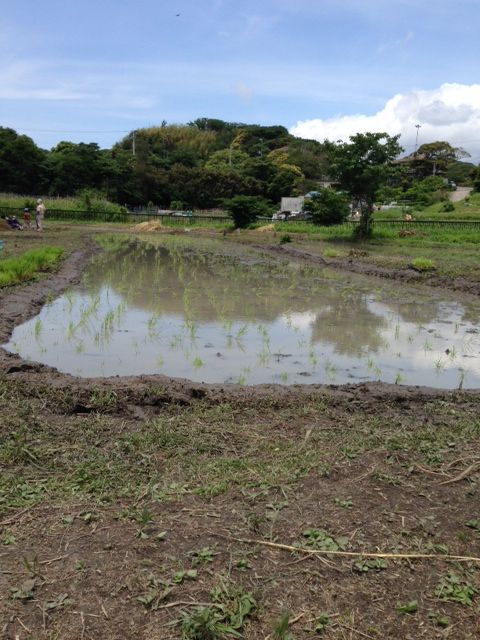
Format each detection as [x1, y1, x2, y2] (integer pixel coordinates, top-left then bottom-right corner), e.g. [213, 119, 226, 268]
[325, 133, 403, 237]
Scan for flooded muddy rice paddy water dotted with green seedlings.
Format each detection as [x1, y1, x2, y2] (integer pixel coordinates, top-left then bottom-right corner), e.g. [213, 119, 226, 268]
[4, 237, 480, 389]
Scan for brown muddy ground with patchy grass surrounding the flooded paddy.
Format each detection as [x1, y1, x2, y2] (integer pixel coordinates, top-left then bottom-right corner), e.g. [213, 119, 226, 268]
[0, 232, 480, 640]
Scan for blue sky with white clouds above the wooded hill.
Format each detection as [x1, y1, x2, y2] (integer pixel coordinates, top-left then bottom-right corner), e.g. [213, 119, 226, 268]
[0, 0, 480, 164]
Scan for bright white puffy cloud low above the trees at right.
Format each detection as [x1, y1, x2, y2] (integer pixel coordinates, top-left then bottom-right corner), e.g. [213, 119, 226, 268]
[290, 83, 480, 161]
